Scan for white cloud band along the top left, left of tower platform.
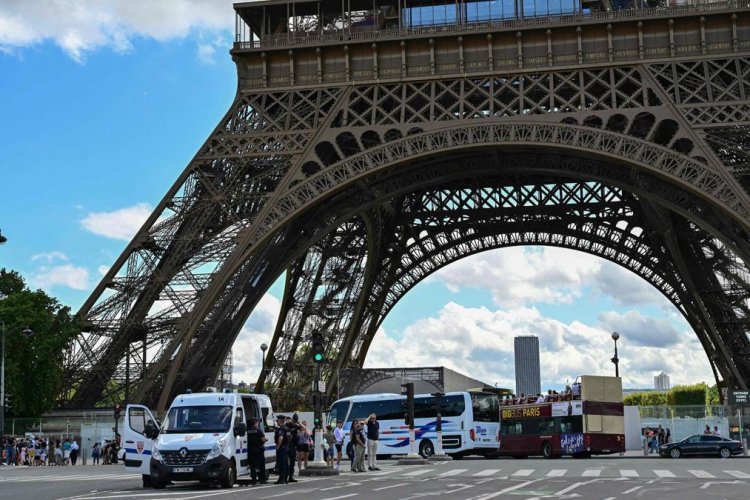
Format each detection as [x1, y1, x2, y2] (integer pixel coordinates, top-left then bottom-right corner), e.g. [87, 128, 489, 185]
[0, 0, 234, 62]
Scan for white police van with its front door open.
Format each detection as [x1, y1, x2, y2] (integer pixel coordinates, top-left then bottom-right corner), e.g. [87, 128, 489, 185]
[123, 388, 276, 488]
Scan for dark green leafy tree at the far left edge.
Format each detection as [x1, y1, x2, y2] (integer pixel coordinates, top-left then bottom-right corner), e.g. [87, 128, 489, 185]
[0, 269, 80, 417]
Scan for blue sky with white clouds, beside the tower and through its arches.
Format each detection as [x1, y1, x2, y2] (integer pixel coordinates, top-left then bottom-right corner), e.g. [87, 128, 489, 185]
[0, 0, 713, 394]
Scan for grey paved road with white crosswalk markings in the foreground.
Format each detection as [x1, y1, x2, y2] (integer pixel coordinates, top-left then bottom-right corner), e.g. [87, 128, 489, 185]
[0, 457, 750, 500]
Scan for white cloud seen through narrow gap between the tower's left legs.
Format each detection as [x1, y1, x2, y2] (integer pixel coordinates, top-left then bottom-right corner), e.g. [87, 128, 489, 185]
[232, 293, 281, 384]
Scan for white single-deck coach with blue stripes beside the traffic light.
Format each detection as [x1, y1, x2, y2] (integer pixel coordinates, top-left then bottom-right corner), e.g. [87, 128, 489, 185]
[328, 391, 500, 458]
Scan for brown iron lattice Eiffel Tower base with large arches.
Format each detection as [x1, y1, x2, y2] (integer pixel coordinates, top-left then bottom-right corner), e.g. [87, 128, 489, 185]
[60, 0, 750, 409]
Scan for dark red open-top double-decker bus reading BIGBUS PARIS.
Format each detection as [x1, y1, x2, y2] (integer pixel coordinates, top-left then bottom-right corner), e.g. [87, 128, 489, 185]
[499, 375, 625, 458]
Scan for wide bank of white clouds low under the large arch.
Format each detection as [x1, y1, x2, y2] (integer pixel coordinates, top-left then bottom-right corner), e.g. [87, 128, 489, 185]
[365, 303, 714, 389]
